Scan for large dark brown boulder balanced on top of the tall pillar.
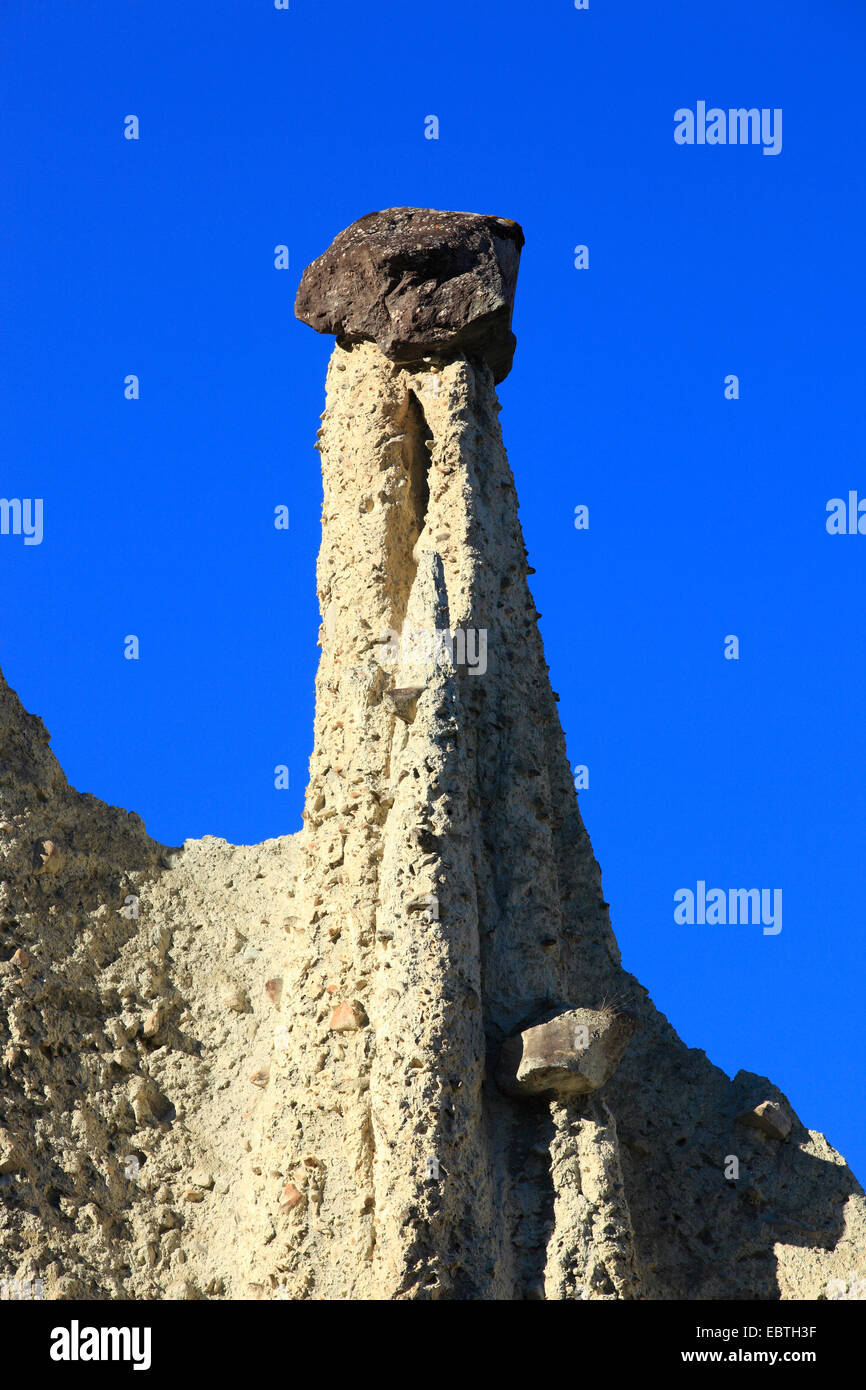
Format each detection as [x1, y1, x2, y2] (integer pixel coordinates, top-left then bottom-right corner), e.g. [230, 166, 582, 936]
[295, 207, 524, 382]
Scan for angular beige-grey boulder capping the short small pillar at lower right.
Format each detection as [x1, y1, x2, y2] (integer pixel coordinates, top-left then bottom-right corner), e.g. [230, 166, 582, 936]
[496, 1009, 637, 1099]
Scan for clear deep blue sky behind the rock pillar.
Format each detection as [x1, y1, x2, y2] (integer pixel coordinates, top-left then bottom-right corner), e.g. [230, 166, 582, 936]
[0, 0, 866, 1179]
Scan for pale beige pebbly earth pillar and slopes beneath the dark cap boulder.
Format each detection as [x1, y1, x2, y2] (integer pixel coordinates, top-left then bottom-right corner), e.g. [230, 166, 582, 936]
[0, 244, 866, 1300]
